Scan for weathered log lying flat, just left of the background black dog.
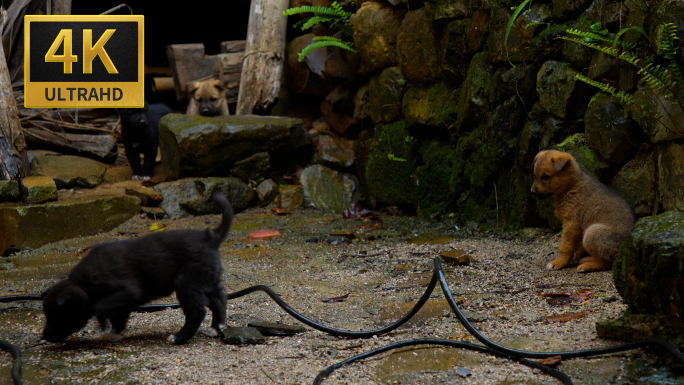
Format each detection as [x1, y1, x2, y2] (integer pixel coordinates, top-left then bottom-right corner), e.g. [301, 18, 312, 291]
[24, 121, 119, 163]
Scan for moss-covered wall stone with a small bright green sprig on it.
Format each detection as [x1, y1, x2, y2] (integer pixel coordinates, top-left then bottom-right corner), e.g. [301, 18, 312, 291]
[363, 120, 416, 204]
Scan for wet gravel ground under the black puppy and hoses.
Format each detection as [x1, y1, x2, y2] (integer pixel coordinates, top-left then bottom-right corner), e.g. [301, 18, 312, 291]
[0, 202, 682, 385]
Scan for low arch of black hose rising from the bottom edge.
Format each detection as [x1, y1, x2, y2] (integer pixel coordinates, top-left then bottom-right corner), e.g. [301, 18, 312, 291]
[313, 338, 572, 385]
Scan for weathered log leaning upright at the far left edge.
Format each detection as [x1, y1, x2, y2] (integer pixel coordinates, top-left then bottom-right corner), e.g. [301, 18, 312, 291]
[0, 9, 29, 180]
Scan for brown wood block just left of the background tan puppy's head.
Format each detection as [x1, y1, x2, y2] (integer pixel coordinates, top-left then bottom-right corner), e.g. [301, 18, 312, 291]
[166, 43, 214, 100]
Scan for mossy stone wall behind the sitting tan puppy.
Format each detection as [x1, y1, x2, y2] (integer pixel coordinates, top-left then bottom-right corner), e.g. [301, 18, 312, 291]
[284, 0, 684, 230]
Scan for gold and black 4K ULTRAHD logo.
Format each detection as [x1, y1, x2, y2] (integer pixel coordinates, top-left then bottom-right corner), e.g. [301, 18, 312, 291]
[24, 15, 144, 108]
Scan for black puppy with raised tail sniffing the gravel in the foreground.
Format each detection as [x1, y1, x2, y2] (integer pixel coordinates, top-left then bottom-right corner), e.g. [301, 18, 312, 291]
[42, 192, 233, 345]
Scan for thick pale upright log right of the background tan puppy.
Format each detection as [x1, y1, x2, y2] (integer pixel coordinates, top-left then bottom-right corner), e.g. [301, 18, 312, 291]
[235, 0, 290, 115]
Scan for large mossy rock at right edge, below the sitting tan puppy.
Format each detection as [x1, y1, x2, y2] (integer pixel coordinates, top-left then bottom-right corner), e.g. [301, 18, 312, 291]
[613, 211, 684, 332]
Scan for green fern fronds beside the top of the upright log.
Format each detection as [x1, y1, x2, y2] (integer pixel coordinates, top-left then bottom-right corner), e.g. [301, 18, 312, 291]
[283, 1, 356, 62]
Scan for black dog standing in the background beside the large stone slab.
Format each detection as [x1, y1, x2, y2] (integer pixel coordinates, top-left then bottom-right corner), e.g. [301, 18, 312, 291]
[119, 102, 173, 180]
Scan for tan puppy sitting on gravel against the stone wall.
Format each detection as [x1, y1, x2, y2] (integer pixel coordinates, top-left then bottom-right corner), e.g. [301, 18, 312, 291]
[531, 150, 635, 272]
